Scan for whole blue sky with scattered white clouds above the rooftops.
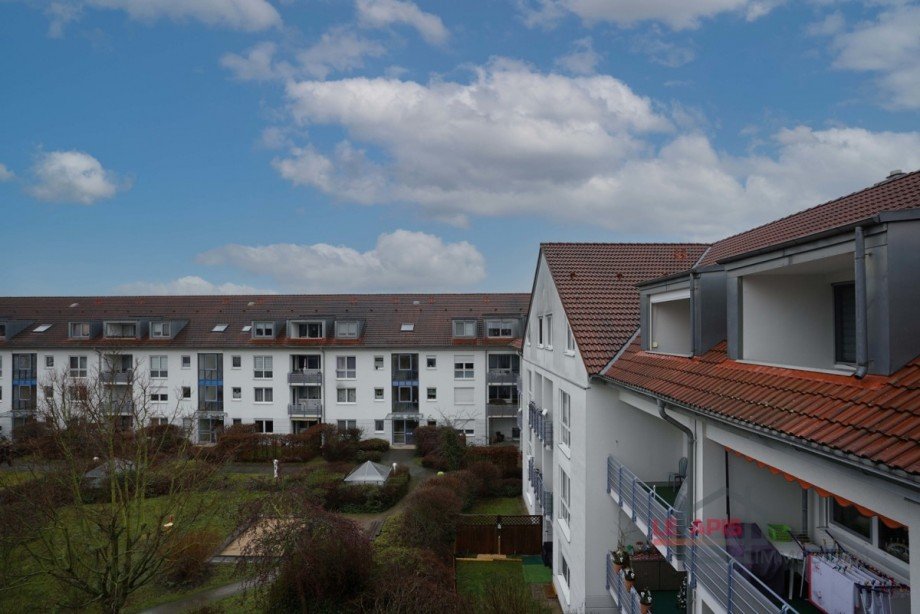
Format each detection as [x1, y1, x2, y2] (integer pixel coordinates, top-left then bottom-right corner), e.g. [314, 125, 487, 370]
[0, 0, 920, 295]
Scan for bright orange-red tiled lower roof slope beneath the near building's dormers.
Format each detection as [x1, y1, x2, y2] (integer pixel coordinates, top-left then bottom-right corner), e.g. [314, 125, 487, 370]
[604, 339, 920, 475]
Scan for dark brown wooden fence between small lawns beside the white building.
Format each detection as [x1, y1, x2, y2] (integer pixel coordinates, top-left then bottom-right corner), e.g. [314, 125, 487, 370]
[454, 514, 543, 555]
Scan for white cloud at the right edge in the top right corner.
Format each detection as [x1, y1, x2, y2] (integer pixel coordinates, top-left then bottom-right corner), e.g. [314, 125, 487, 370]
[832, 4, 920, 109]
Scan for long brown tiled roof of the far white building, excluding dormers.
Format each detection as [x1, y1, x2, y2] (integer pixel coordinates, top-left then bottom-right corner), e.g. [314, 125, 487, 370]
[0, 294, 530, 349]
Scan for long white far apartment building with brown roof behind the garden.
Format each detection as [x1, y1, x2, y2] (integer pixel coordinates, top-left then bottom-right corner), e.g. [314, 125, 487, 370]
[0, 294, 529, 444]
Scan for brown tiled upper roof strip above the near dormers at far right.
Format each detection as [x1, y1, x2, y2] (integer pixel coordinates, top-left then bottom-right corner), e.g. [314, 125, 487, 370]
[699, 171, 920, 266]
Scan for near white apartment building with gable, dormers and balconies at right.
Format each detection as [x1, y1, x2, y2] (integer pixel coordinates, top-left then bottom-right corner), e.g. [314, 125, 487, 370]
[521, 172, 920, 614]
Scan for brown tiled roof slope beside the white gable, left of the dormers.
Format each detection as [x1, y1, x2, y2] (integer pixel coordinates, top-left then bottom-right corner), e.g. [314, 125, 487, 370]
[541, 243, 706, 374]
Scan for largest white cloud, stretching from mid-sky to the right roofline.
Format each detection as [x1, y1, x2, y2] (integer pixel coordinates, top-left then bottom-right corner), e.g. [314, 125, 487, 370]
[274, 61, 920, 239]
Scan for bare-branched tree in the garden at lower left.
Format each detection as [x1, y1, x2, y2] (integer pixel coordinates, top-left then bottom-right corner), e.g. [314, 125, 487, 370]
[8, 354, 219, 612]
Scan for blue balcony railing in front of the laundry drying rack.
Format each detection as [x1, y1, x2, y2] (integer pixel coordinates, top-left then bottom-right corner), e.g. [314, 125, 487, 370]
[687, 535, 797, 614]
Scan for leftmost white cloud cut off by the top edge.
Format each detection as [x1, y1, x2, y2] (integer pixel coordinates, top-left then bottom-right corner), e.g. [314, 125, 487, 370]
[86, 0, 281, 32]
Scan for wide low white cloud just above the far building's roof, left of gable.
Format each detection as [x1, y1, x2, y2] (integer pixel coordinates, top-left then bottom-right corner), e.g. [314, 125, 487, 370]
[198, 230, 485, 292]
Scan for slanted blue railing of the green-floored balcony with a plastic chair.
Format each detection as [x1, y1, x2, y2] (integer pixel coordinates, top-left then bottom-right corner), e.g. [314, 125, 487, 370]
[607, 456, 687, 567]
